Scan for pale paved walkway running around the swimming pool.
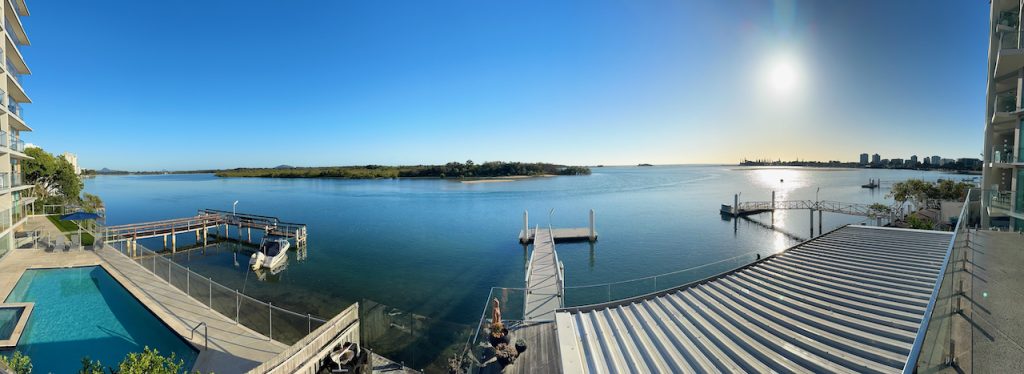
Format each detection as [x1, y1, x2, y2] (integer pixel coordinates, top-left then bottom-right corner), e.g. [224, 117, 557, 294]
[0, 224, 286, 373]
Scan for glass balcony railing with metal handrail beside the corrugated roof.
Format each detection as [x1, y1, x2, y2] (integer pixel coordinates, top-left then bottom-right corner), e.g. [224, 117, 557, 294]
[903, 189, 982, 374]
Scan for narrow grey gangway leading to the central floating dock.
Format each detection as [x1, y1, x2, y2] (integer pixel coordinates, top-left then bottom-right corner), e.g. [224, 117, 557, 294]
[523, 230, 563, 322]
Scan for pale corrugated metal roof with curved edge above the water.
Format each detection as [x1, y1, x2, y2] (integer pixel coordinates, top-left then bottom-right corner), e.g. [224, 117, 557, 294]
[556, 226, 950, 373]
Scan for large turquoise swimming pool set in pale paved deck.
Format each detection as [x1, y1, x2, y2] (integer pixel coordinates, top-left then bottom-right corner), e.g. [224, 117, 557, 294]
[5, 266, 199, 373]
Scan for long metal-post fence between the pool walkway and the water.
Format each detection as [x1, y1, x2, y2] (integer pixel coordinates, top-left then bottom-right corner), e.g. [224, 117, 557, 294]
[110, 238, 327, 344]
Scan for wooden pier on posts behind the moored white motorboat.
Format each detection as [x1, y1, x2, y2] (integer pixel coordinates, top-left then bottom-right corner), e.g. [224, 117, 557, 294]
[101, 209, 307, 251]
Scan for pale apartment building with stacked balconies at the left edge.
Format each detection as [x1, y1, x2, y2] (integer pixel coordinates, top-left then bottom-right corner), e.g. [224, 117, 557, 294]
[0, 0, 34, 257]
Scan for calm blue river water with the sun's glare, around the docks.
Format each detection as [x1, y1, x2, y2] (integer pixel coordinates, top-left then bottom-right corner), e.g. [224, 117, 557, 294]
[86, 166, 963, 367]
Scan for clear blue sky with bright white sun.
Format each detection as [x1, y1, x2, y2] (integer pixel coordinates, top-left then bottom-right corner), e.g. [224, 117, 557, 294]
[23, 0, 989, 170]
